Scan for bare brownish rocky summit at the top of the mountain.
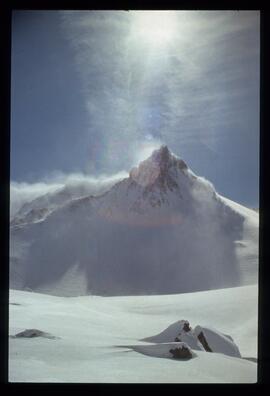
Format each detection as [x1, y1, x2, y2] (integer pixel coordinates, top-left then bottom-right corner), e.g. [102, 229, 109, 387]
[130, 145, 187, 187]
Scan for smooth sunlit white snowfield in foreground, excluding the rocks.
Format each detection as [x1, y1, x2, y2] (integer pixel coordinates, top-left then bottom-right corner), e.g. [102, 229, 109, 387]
[9, 285, 258, 383]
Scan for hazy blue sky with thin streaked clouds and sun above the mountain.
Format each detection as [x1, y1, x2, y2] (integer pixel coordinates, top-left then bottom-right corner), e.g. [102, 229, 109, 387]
[11, 10, 260, 207]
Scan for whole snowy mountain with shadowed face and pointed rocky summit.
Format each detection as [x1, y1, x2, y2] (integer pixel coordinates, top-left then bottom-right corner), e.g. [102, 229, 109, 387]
[10, 146, 258, 296]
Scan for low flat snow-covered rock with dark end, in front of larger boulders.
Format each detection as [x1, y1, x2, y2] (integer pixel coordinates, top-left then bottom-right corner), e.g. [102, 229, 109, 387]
[129, 342, 197, 360]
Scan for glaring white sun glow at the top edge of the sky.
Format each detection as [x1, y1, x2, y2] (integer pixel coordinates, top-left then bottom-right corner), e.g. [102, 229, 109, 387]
[132, 10, 176, 46]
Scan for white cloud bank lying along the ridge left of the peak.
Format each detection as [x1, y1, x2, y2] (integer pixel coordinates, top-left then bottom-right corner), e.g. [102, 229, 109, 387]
[10, 171, 127, 218]
